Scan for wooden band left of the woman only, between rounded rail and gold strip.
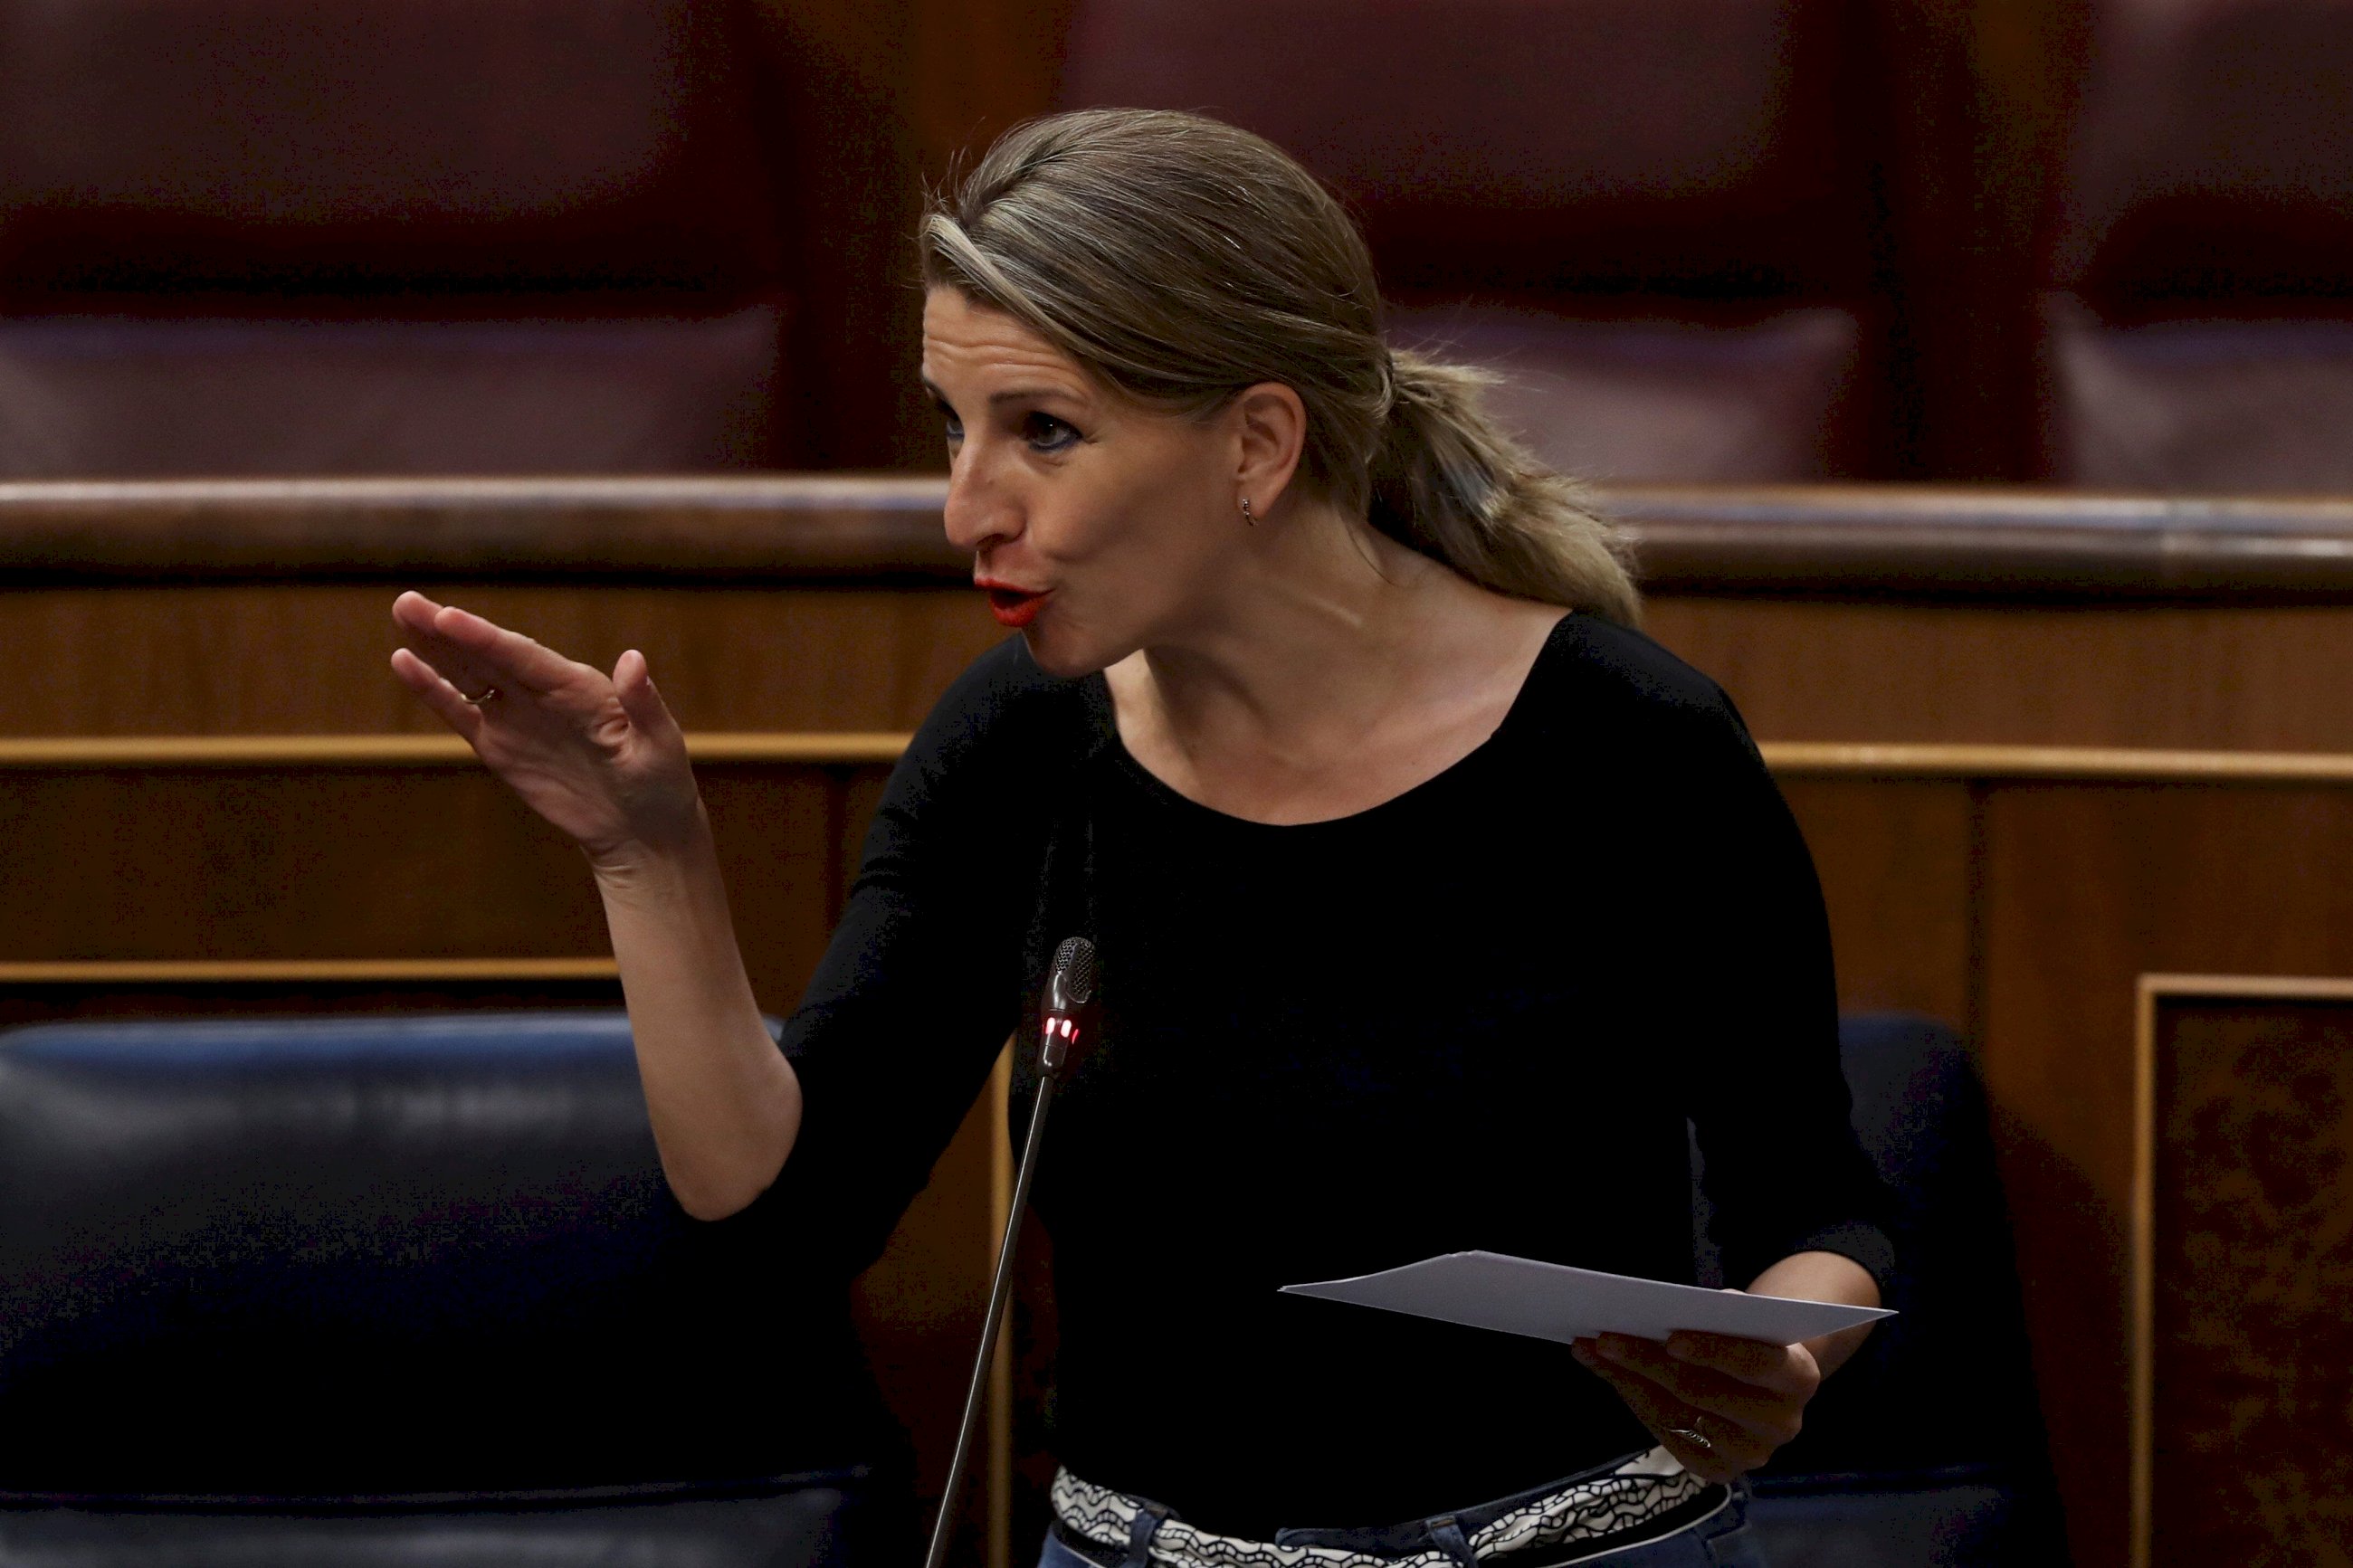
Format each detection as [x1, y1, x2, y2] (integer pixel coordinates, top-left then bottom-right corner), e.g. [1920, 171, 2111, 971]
[0, 581, 1005, 736]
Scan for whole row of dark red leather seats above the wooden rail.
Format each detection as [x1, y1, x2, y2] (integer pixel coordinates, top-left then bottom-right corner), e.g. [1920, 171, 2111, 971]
[0, 0, 2353, 491]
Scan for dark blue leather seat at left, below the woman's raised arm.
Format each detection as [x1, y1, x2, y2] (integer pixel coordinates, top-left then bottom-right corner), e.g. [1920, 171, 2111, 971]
[0, 1011, 910, 1568]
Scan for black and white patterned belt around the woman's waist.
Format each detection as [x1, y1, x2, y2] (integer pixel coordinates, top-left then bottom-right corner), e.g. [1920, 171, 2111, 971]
[1052, 1448, 1725, 1568]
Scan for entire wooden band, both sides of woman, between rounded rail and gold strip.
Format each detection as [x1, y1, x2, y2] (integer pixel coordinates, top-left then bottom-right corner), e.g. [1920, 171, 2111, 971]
[27, 581, 2353, 752]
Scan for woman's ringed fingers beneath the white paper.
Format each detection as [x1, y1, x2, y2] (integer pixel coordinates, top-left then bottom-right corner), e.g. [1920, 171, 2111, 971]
[1572, 1331, 1821, 1481]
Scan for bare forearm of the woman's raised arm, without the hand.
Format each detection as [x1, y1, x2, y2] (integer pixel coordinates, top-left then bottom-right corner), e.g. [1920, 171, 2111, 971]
[595, 816, 800, 1220]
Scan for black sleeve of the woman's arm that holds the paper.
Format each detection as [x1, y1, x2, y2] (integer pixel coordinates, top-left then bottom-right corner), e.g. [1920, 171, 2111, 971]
[1662, 689, 1894, 1296]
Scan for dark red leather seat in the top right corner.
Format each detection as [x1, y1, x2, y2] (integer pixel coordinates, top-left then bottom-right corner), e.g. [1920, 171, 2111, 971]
[2040, 0, 2353, 491]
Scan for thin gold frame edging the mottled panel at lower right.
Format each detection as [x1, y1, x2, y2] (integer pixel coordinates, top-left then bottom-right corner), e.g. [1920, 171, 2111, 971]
[2127, 974, 2353, 1568]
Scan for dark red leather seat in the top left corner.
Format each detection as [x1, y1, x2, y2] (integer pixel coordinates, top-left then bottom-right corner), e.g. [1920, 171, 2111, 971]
[0, 0, 795, 477]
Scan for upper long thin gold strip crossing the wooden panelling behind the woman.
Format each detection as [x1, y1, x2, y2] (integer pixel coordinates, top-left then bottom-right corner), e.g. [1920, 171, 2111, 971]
[0, 728, 2353, 783]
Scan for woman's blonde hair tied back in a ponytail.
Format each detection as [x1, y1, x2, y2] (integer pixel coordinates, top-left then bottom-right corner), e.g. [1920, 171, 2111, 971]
[922, 109, 1640, 625]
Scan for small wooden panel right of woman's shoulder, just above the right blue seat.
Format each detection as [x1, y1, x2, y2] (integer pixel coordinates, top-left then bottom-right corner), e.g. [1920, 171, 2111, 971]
[1781, 778, 1977, 1030]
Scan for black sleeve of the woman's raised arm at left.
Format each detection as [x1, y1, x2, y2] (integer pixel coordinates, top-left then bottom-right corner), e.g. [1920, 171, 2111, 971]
[722, 640, 1075, 1272]
